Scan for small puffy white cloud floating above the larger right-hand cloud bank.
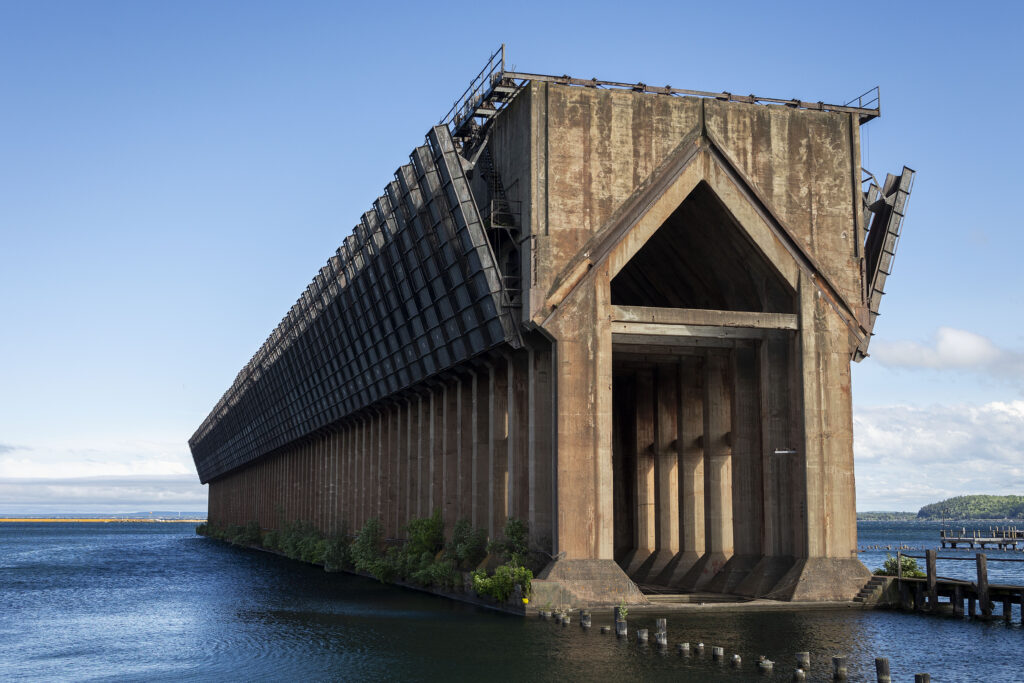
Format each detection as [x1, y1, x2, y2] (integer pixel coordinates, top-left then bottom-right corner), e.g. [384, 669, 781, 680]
[871, 327, 1024, 377]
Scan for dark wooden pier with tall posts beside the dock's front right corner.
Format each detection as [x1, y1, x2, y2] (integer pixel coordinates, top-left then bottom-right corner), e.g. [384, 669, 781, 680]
[896, 550, 1024, 622]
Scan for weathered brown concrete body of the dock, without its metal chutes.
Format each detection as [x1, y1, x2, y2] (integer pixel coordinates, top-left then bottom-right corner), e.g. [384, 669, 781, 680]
[199, 77, 888, 604]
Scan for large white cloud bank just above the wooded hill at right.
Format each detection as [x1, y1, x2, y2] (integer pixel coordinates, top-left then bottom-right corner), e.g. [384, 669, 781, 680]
[853, 400, 1024, 511]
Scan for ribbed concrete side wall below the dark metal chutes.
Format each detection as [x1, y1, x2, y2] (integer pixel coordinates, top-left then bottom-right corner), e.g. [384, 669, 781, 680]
[209, 343, 553, 551]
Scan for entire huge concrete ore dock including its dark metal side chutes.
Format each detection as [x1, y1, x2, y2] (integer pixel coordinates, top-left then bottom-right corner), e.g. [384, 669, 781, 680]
[189, 51, 913, 605]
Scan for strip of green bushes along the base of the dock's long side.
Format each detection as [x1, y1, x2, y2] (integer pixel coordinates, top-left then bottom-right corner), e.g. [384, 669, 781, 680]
[196, 510, 543, 602]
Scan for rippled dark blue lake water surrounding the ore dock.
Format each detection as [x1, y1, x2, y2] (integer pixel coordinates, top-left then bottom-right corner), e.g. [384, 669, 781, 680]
[0, 523, 1024, 681]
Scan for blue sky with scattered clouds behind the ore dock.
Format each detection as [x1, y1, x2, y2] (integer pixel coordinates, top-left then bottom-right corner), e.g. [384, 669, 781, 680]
[0, 0, 1024, 513]
